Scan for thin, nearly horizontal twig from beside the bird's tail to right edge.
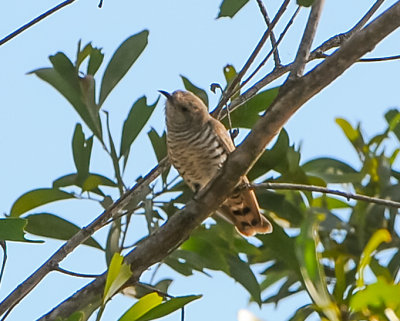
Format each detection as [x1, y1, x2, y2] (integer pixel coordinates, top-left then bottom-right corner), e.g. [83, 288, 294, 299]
[255, 183, 400, 208]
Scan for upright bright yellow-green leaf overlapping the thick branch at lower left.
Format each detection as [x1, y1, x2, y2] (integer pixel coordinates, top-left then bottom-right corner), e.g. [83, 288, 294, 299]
[103, 253, 132, 304]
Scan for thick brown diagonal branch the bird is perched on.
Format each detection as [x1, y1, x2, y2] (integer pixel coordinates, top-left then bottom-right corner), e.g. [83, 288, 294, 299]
[41, 1, 400, 320]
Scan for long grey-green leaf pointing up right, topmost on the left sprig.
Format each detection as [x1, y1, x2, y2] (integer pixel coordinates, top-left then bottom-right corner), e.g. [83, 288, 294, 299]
[99, 30, 149, 106]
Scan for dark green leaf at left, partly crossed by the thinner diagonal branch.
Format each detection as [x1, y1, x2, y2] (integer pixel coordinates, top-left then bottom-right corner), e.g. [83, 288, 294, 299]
[25, 213, 102, 250]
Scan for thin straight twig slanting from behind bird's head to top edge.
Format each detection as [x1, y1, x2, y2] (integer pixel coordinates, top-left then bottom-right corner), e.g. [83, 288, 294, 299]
[211, 0, 290, 119]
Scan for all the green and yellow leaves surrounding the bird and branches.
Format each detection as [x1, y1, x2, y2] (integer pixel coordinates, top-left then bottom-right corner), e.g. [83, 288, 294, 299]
[0, 0, 400, 321]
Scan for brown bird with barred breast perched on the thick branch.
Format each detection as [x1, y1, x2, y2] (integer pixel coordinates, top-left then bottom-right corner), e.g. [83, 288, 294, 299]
[159, 90, 272, 236]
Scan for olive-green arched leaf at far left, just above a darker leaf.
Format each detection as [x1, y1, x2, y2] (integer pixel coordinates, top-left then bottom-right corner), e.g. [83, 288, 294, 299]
[10, 188, 74, 217]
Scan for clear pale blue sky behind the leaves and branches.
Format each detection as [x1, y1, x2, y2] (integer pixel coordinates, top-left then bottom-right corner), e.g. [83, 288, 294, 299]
[0, 0, 400, 321]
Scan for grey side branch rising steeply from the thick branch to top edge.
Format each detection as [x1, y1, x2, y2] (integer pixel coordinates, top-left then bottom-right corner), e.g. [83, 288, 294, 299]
[289, 0, 325, 80]
